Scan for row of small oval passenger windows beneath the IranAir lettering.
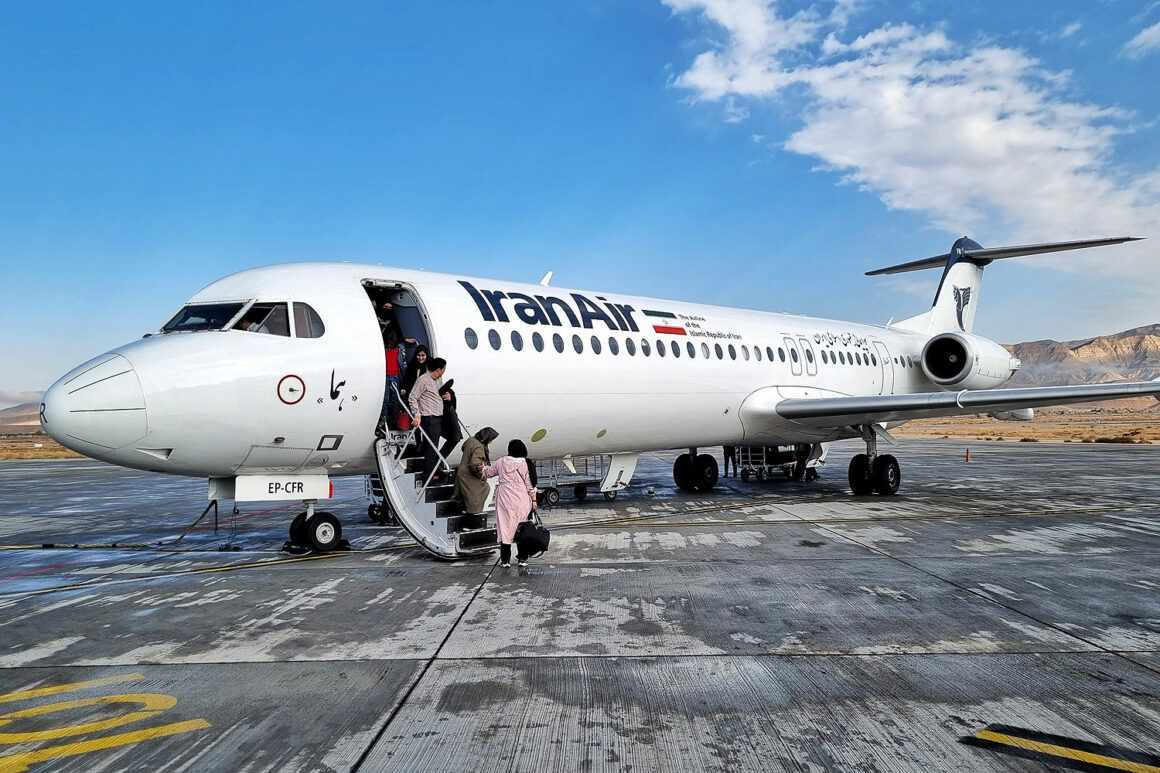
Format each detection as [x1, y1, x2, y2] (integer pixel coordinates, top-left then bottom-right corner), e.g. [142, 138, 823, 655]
[463, 327, 918, 367]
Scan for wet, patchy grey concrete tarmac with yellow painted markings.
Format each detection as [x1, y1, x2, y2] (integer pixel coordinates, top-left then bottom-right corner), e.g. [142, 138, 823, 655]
[0, 441, 1160, 773]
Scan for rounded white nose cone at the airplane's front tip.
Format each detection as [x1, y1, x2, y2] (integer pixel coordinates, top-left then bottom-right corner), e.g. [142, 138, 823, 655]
[41, 354, 148, 448]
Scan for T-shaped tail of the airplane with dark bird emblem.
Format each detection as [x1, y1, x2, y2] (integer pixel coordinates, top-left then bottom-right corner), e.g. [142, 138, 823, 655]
[867, 237, 1139, 333]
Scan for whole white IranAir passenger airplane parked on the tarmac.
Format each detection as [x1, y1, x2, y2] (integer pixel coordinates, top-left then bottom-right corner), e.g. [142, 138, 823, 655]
[41, 237, 1160, 558]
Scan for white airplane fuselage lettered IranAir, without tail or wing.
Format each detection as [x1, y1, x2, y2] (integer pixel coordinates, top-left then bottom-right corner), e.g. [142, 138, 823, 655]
[42, 263, 1010, 477]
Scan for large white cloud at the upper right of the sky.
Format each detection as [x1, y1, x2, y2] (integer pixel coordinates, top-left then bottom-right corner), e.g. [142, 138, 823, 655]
[666, 0, 1160, 290]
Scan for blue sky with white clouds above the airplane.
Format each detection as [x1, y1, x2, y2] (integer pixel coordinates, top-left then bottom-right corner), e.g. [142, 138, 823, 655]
[0, 0, 1160, 405]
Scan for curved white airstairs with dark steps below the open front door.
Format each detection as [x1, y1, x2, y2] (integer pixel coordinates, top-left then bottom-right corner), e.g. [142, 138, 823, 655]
[375, 433, 499, 561]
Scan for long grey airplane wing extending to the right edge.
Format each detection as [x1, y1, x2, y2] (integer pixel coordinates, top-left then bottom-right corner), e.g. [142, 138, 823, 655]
[774, 380, 1160, 427]
